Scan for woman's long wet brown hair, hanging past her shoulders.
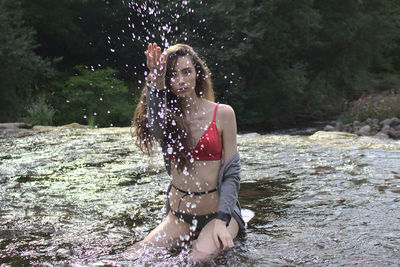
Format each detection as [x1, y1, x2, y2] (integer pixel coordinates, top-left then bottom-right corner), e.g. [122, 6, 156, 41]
[132, 44, 215, 172]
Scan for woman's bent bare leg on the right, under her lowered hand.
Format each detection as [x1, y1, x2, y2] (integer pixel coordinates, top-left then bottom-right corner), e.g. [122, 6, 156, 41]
[191, 217, 239, 262]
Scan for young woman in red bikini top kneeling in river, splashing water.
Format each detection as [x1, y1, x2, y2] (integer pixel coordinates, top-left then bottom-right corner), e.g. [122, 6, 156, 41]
[133, 43, 245, 261]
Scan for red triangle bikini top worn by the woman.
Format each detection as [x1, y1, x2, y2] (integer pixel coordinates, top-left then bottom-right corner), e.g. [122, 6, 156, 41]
[169, 104, 222, 161]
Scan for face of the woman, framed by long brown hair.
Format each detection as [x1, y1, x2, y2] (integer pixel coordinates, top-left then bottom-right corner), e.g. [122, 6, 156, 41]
[169, 56, 196, 96]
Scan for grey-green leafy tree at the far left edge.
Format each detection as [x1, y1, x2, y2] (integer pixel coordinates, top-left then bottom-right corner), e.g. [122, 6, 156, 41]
[0, 0, 53, 120]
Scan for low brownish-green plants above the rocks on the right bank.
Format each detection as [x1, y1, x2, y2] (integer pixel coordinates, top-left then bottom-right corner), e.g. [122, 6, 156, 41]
[340, 90, 400, 123]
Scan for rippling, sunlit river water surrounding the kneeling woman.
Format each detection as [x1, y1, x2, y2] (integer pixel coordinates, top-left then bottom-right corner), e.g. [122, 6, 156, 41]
[0, 128, 400, 266]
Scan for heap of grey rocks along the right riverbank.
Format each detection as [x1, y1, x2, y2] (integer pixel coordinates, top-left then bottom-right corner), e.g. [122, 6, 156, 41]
[324, 117, 400, 140]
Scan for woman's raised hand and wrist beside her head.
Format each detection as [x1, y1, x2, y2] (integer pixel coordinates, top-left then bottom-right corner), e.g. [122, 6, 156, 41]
[144, 43, 168, 89]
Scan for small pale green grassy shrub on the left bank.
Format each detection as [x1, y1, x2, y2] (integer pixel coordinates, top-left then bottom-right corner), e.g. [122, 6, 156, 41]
[28, 97, 55, 126]
